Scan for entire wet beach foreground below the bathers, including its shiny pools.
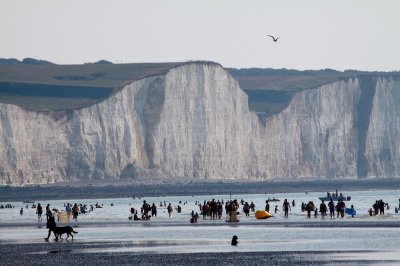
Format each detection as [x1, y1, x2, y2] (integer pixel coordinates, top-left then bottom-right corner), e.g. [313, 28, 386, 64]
[0, 221, 400, 266]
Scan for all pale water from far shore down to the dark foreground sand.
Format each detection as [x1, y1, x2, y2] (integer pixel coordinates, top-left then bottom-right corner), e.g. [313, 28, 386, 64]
[0, 190, 400, 260]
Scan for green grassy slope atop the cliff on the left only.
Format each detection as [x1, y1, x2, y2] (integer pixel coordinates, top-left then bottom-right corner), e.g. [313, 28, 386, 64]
[0, 59, 180, 110]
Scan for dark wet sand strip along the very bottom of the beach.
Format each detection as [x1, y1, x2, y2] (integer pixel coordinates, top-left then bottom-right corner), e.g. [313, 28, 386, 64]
[0, 242, 400, 266]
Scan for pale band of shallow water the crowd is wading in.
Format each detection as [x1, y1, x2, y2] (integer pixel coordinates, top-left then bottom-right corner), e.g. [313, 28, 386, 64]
[0, 190, 400, 225]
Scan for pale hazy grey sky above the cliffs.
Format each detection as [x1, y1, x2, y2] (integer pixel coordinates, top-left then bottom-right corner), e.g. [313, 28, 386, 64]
[0, 0, 400, 71]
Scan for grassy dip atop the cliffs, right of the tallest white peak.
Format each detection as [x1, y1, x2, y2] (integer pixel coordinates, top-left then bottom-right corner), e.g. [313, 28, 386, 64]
[229, 68, 400, 115]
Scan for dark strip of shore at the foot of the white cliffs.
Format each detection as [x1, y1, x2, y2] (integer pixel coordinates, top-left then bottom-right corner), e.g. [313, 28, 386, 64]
[0, 178, 400, 201]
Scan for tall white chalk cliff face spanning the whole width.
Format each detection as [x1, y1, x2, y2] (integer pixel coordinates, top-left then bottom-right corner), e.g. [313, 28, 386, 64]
[0, 64, 400, 184]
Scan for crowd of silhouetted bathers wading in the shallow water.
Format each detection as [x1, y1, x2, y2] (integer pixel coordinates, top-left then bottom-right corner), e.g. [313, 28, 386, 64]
[5, 198, 400, 228]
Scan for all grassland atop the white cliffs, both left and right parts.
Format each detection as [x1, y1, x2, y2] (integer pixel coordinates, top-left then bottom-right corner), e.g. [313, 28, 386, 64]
[0, 58, 400, 112]
